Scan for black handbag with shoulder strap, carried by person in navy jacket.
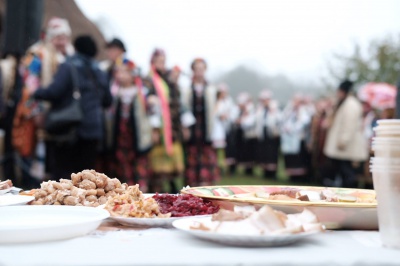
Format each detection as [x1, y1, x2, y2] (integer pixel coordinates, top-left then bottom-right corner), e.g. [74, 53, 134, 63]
[44, 63, 83, 135]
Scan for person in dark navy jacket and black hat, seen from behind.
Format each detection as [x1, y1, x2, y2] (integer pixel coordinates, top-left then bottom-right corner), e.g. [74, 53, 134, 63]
[33, 36, 112, 179]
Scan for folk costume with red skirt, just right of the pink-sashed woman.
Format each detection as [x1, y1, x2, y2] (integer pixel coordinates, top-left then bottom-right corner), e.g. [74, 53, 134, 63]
[182, 83, 220, 186]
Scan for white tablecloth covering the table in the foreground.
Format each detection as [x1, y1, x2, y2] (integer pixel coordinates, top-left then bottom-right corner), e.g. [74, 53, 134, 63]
[0, 220, 400, 266]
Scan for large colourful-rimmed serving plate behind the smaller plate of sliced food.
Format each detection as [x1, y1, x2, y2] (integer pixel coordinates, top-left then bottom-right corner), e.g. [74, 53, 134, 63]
[181, 186, 378, 230]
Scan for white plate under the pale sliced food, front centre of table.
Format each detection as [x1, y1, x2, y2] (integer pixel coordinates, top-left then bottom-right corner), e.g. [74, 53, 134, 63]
[172, 217, 317, 247]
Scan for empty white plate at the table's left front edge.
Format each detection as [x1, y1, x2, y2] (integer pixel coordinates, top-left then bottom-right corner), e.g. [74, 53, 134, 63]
[0, 205, 110, 244]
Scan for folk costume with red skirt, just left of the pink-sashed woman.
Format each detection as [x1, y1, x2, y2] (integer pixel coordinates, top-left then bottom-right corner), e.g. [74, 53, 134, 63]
[111, 75, 152, 192]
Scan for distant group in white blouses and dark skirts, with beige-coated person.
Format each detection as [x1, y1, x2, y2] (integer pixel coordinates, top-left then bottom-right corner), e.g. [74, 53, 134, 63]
[222, 80, 388, 187]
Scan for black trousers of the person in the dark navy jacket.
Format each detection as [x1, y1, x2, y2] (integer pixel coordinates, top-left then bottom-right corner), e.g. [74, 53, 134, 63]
[50, 139, 98, 180]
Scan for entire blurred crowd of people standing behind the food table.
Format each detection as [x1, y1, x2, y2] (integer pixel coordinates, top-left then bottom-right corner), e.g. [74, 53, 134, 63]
[0, 18, 393, 193]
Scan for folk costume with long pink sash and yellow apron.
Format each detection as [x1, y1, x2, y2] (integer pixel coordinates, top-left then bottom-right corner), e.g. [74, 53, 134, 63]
[149, 68, 184, 190]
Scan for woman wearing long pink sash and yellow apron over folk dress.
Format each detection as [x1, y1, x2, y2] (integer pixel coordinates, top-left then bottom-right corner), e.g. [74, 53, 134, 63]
[148, 49, 194, 193]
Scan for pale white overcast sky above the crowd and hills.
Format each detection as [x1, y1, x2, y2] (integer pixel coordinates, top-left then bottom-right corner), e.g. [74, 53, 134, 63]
[77, 0, 400, 85]
